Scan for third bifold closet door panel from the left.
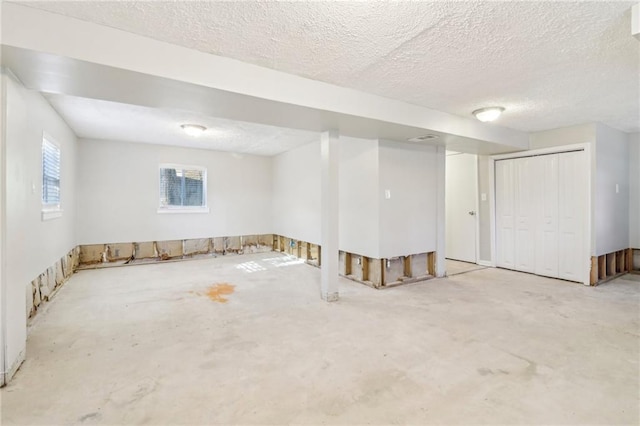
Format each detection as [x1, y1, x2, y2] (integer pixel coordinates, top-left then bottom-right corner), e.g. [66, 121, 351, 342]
[535, 154, 559, 278]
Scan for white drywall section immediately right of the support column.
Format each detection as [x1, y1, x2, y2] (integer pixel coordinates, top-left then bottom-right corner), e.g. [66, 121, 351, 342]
[340, 137, 380, 258]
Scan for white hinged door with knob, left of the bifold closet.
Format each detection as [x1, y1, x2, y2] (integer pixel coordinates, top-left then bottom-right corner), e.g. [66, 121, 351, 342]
[445, 153, 478, 263]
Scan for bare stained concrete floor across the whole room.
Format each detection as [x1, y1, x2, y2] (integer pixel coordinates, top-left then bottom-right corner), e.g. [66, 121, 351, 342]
[1, 253, 640, 425]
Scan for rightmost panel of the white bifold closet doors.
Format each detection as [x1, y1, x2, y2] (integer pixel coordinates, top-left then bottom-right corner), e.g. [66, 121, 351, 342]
[558, 151, 589, 281]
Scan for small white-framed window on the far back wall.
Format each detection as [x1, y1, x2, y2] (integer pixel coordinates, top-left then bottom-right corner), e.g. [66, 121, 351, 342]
[158, 164, 209, 213]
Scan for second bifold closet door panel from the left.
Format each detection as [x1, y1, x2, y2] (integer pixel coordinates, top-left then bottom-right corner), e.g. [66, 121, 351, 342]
[513, 157, 538, 272]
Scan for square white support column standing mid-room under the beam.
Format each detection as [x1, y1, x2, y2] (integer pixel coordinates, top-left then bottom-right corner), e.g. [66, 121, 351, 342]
[320, 130, 339, 302]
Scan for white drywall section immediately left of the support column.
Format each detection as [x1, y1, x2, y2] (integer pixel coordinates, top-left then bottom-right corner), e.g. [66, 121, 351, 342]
[269, 140, 320, 244]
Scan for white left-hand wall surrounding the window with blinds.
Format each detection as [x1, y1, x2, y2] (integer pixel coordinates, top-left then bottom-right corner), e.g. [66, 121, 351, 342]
[2, 71, 77, 378]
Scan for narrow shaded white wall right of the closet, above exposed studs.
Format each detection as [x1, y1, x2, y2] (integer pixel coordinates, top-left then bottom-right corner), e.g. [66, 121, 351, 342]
[593, 123, 629, 256]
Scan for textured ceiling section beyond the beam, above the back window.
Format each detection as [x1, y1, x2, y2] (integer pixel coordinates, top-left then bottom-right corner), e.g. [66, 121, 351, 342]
[45, 95, 320, 156]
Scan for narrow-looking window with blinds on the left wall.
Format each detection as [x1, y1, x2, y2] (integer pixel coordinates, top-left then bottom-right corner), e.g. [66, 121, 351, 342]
[42, 134, 62, 220]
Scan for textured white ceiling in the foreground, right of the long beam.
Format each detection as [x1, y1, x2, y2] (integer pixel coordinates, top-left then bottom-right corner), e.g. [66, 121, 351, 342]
[23, 1, 640, 131]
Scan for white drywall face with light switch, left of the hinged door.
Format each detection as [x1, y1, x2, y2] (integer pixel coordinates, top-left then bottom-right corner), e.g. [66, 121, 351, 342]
[378, 140, 438, 258]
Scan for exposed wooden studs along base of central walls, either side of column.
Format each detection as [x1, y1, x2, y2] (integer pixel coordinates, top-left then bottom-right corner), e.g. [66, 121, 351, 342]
[273, 235, 436, 288]
